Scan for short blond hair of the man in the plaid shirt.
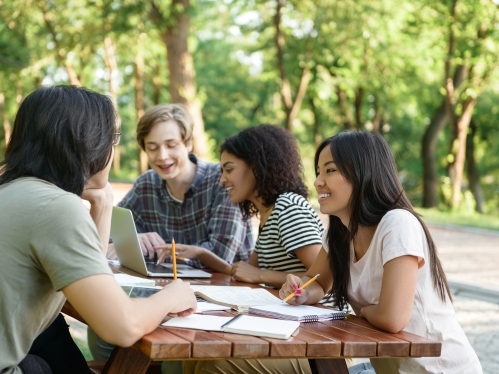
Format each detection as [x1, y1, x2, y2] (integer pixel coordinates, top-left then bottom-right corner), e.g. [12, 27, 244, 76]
[137, 104, 194, 150]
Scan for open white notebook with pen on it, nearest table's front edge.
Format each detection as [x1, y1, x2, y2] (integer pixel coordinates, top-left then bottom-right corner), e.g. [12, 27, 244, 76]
[162, 314, 300, 339]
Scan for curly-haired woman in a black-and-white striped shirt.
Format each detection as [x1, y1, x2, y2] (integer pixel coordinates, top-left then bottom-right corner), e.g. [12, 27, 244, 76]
[220, 125, 323, 287]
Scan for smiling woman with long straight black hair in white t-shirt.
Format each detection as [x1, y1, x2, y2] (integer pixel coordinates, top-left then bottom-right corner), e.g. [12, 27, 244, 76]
[280, 132, 482, 374]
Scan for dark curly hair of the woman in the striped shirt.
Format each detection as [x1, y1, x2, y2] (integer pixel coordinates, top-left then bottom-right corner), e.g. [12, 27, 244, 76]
[220, 125, 308, 219]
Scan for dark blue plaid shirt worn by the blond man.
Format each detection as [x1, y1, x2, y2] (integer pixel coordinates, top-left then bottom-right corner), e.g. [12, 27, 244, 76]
[118, 153, 253, 267]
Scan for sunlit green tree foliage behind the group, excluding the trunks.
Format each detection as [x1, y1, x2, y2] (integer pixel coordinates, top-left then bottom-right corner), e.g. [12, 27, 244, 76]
[0, 0, 499, 215]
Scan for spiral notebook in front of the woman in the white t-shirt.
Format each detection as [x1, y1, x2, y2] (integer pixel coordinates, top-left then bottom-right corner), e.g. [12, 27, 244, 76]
[249, 304, 346, 322]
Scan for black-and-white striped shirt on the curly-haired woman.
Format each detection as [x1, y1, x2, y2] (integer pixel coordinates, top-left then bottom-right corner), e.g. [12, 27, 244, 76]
[255, 192, 324, 272]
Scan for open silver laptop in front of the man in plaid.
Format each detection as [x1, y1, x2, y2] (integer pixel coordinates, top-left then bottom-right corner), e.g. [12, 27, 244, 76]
[111, 206, 211, 278]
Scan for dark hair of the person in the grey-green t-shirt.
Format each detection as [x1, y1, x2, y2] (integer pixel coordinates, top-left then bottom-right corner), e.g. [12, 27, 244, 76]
[0, 86, 117, 196]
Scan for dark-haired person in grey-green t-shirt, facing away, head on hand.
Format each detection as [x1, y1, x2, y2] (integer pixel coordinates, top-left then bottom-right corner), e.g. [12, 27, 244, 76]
[0, 86, 196, 374]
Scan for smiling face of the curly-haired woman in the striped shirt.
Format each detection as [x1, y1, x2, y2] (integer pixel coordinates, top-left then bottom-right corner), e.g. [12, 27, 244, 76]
[220, 152, 256, 203]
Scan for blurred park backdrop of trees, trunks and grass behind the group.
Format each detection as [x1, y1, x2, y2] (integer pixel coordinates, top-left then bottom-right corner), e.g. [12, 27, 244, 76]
[0, 0, 499, 225]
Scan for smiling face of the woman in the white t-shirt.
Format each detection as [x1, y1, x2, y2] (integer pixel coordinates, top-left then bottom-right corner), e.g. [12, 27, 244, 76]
[314, 146, 353, 227]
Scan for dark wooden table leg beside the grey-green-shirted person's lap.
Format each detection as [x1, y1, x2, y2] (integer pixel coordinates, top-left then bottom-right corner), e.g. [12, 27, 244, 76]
[102, 346, 151, 374]
